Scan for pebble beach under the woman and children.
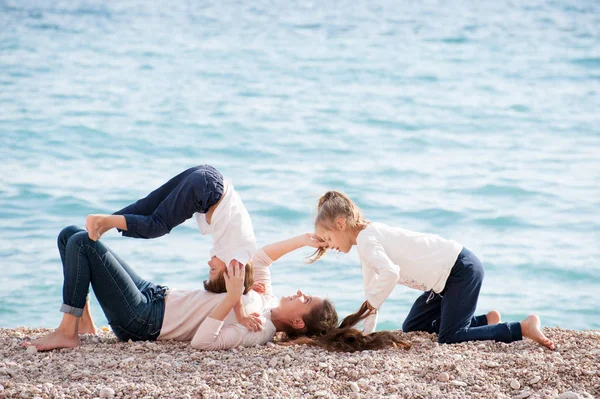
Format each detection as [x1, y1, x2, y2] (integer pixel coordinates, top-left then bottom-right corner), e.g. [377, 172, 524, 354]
[0, 327, 600, 399]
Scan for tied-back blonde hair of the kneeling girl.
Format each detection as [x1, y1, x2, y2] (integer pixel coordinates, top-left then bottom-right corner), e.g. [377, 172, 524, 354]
[308, 190, 369, 263]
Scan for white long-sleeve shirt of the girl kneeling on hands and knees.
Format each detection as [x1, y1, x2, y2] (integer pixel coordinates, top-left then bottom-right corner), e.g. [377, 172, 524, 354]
[356, 222, 463, 332]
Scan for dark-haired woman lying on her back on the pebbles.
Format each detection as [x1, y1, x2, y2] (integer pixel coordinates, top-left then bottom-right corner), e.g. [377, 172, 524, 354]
[24, 226, 409, 351]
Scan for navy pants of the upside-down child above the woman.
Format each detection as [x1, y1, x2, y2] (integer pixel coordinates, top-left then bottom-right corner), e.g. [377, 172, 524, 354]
[114, 165, 223, 238]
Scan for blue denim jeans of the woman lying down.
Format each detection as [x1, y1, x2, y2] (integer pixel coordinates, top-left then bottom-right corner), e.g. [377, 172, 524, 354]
[58, 226, 166, 341]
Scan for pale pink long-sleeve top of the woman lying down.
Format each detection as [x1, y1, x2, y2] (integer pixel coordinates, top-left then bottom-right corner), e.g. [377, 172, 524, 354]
[158, 249, 278, 350]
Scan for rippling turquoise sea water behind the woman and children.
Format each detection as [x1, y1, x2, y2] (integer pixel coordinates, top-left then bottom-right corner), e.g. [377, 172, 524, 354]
[0, 0, 600, 329]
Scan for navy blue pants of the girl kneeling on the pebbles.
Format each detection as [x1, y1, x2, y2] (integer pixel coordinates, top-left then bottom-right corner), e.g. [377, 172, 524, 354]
[402, 248, 523, 344]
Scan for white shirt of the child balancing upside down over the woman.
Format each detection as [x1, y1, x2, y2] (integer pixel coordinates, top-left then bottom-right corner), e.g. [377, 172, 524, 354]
[194, 180, 256, 265]
